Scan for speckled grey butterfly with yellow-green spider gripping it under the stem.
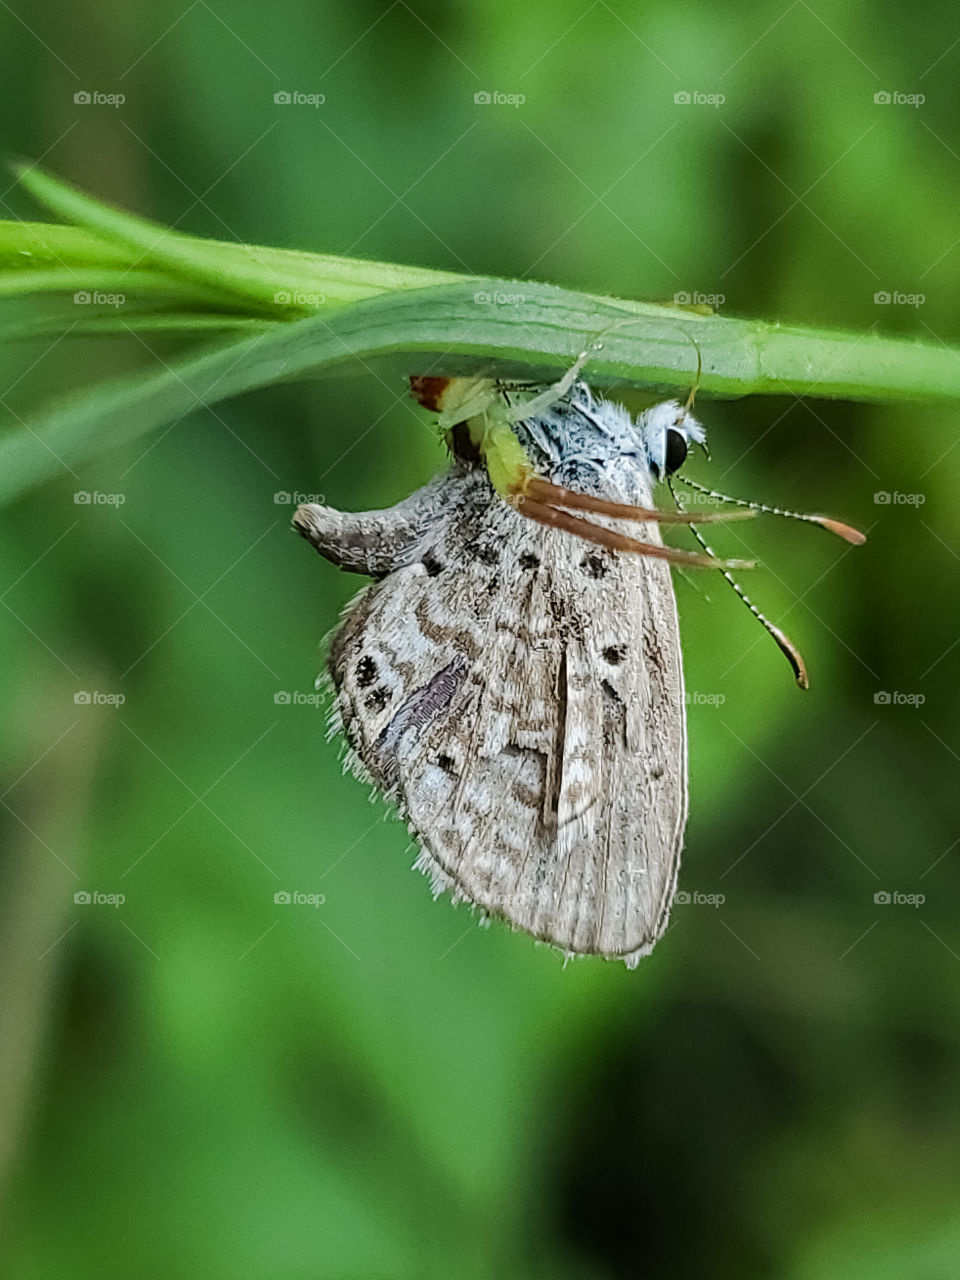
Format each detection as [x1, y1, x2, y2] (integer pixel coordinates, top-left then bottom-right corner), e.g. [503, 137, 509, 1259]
[293, 357, 863, 968]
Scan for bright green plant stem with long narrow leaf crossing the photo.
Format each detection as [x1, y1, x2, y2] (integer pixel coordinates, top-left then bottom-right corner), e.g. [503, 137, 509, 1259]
[0, 157, 960, 499]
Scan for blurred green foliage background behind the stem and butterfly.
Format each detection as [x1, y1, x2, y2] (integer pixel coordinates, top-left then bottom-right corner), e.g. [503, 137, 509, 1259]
[0, 0, 960, 1280]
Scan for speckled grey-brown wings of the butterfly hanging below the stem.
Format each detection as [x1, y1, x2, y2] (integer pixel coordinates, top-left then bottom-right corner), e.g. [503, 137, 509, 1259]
[330, 475, 686, 963]
